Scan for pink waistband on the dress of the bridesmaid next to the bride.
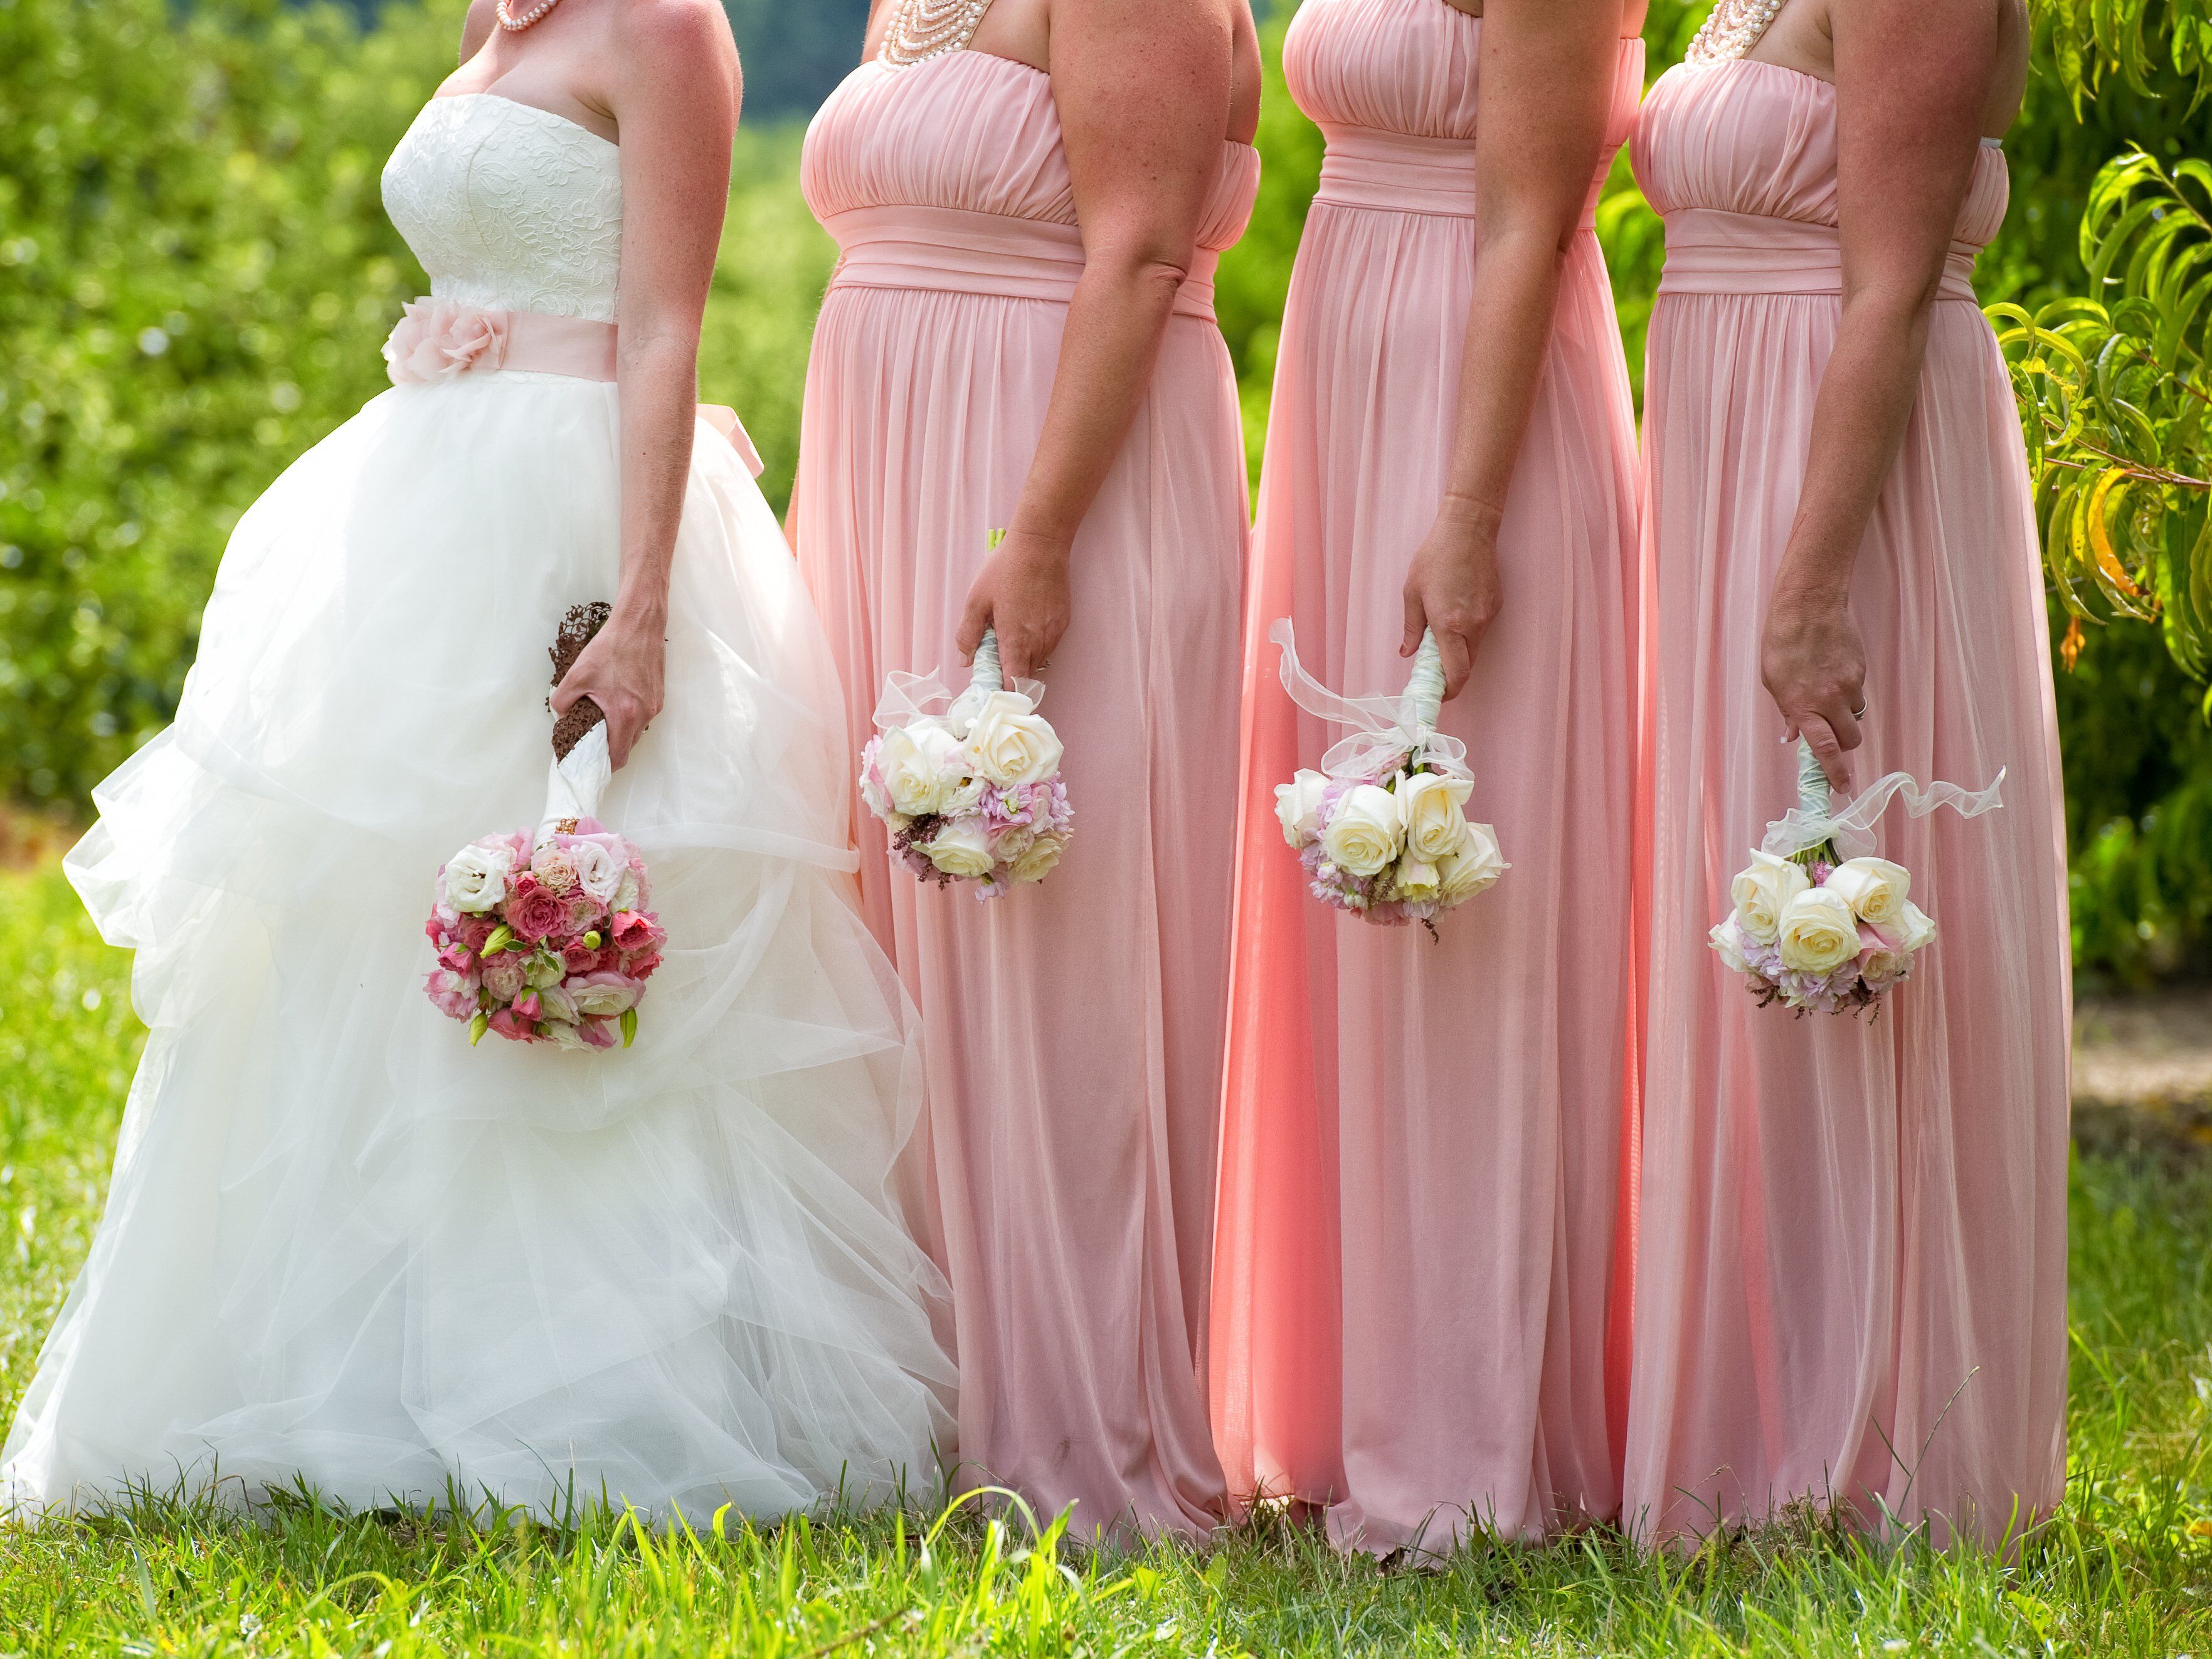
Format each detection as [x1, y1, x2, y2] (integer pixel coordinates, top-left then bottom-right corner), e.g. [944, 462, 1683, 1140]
[823, 206, 1221, 323]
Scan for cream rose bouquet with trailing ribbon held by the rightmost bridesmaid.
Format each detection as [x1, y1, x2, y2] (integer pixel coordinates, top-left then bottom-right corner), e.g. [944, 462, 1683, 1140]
[1712, 739, 2004, 1015]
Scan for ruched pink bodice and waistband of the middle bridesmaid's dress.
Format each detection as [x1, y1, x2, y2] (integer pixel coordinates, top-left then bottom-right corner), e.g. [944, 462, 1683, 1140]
[1283, 0, 1644, 215]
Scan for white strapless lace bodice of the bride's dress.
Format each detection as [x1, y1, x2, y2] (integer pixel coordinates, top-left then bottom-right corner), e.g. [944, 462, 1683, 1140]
[385, 93, 622, 323]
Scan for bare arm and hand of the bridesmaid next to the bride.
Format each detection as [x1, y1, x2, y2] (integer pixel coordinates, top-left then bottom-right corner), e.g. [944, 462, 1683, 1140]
[960, 0, 1234, 675]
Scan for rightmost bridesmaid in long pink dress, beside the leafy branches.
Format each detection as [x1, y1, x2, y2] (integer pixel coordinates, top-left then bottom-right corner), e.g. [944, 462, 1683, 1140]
[1626, 0, 2070, 1544]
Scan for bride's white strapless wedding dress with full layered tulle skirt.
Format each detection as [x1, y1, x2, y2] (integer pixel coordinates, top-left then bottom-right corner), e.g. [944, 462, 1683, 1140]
[0, 95, 953, 1522]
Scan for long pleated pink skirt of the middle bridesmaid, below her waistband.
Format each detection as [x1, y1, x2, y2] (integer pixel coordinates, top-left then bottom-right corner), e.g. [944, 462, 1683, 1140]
[1212, 201, 1637, 1553]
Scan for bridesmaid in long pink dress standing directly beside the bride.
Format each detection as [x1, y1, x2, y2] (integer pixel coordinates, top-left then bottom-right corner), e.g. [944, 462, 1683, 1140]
[796, 0, 1261, 1535]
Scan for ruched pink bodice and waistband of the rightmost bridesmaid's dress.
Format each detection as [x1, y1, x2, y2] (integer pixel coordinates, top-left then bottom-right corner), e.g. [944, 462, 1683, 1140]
[1633, 58, 2011, 299]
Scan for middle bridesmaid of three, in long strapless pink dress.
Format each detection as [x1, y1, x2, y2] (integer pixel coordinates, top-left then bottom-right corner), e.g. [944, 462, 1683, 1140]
[1212, 0, 1644, 1553]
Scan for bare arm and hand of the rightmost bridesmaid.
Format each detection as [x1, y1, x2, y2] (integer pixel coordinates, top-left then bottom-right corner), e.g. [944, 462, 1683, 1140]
[1759, 0, 1998, 790]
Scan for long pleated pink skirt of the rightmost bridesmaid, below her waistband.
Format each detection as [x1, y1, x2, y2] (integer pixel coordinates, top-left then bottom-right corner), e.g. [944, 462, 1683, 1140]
[1624, 294, 2070, 1544]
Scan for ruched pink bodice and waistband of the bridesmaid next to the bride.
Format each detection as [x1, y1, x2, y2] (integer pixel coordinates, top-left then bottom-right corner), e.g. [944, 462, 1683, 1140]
[798, 51, 1259, 314]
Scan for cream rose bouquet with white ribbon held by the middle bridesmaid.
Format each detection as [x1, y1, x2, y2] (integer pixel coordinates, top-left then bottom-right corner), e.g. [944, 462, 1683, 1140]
[1267, 617, 1511, 936]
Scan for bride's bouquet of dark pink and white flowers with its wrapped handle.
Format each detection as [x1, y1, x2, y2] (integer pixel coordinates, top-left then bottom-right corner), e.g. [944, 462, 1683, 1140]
[423, 604, 668, 1049]
